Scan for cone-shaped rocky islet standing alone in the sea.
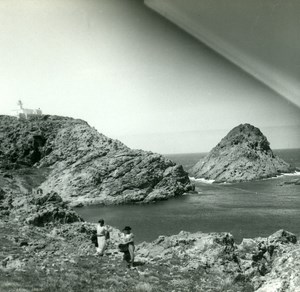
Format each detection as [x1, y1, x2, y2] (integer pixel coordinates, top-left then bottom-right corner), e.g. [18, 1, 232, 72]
[190, 124, 294, 182]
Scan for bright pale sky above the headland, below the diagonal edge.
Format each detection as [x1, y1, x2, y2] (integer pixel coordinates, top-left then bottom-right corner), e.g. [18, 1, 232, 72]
[0, 0, 300, 154]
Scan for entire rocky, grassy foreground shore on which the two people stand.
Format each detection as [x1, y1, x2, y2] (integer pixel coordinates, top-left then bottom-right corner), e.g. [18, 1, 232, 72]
[0, 190, 300, 292]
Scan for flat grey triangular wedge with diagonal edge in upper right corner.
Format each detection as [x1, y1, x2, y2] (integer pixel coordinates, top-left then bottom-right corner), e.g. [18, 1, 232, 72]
[145, 0, 300, 106]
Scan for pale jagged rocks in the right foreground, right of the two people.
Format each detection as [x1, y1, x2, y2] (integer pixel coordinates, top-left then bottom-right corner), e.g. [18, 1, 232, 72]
[137, 230, 300, 292]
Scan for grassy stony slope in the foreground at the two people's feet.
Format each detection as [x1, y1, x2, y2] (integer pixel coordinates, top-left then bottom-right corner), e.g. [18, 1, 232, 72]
[0, 222, 252, 292]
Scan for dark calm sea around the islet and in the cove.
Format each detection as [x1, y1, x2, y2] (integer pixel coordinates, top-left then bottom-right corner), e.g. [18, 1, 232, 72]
[76, 149, 300, 243]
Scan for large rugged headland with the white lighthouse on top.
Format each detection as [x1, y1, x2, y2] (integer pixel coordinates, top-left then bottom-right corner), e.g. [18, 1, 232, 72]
[0, 116, 193, 204]
